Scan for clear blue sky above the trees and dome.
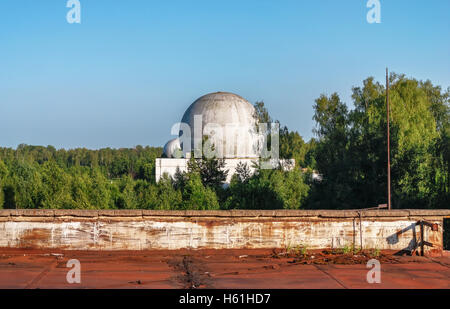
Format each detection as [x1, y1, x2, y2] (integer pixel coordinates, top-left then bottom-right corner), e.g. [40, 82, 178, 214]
[0, 0, 450, 148]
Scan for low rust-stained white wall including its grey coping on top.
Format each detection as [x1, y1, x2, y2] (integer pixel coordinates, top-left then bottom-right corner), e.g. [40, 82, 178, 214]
[0, 210, 450, 254]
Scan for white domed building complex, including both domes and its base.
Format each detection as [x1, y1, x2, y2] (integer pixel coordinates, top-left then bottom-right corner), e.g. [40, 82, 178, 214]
[155, 92, 295, 182]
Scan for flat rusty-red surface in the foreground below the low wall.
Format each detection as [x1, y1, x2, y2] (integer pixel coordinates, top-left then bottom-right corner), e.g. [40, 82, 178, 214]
[0, 249, 450, 289]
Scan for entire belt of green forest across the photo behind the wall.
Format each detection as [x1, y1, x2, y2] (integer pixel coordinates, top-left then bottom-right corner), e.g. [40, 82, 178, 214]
[0, 74, 450, 209]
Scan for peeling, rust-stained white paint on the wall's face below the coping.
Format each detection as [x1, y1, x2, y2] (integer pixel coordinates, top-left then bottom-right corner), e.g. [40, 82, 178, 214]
[0, 209, 442, 252]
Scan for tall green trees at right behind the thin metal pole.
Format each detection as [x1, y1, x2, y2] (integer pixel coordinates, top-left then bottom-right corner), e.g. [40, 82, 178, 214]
[311, 74, 448, 208]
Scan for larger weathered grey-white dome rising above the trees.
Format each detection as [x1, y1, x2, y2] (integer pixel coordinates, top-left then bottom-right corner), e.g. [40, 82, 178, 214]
[179, 92, 260, 158]
